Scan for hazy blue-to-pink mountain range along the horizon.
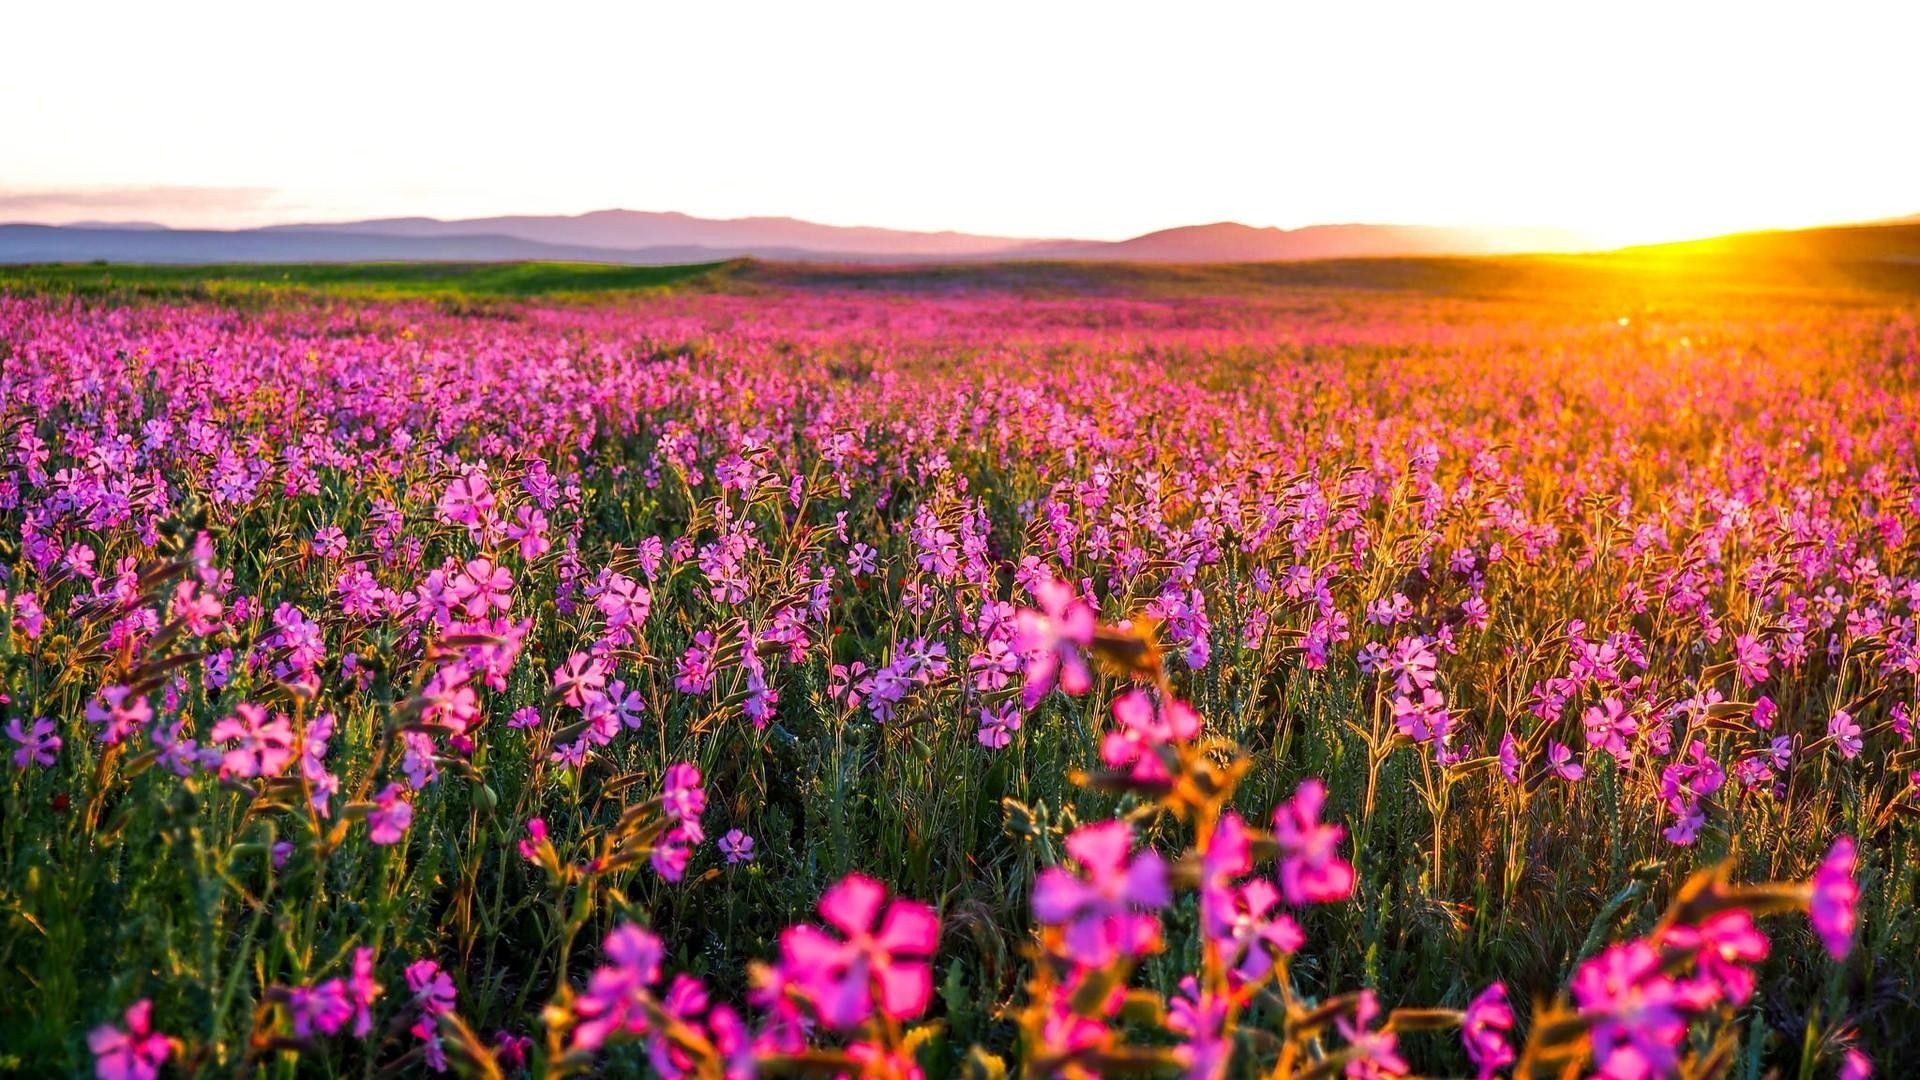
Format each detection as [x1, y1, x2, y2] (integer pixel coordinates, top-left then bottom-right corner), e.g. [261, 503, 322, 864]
[0, 209, 1580, 265]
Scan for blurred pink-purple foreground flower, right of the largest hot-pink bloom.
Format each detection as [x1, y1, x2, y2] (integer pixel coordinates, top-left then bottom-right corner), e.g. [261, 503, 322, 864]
[1033, 821, 1173, 967]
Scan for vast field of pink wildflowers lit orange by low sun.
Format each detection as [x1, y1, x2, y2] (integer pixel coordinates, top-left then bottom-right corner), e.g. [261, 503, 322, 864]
[0, 278, 1920, 1080]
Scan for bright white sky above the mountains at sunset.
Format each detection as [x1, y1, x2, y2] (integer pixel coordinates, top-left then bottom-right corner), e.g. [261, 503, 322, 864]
[0, 0, 1920, 242]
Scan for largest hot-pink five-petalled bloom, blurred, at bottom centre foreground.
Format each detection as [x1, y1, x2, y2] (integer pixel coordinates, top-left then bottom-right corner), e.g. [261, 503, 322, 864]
[780, 874, 941, 1032]
